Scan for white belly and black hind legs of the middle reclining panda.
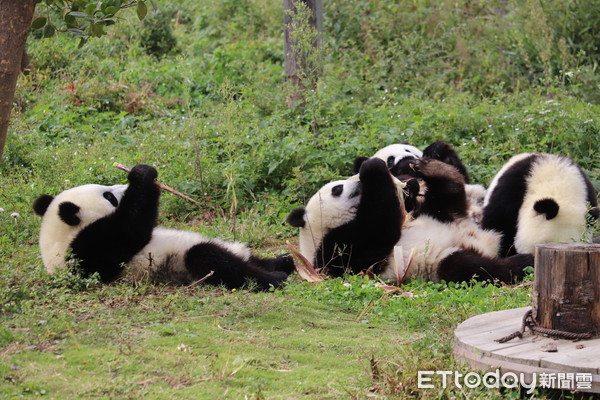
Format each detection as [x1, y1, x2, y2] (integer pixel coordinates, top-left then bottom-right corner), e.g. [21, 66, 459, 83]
[396, 158, 533, 283]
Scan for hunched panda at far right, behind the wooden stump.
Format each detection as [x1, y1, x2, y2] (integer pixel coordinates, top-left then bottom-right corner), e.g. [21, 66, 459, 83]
[481, 153, 599, 256]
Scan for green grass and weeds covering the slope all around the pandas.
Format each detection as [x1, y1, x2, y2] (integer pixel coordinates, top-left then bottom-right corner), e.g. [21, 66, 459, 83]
[0, 0, 600, 400]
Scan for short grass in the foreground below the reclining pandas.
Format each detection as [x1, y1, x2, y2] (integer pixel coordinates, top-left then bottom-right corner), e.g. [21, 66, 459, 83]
[0, 277, 527, 399]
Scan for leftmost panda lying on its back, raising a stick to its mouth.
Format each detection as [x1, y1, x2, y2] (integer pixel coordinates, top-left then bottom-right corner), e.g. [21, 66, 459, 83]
[33, 165, 293, 289]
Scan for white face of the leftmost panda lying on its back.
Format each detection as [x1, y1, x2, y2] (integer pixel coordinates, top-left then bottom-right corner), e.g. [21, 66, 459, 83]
[36, 185, 127, 272]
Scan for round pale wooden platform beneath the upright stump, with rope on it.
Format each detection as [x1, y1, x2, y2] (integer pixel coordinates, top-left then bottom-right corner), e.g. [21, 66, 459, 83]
[454, 307, 600, 393]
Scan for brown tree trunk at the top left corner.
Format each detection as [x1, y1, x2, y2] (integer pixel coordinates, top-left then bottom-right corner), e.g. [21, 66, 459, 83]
[0, 0, 35, 162]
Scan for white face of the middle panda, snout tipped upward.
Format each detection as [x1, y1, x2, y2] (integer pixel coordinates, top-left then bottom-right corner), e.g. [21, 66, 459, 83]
[296, 175, 361, 262]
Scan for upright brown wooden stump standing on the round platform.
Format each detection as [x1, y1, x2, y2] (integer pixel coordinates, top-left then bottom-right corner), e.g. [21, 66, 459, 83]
[532, 243, 600, 335]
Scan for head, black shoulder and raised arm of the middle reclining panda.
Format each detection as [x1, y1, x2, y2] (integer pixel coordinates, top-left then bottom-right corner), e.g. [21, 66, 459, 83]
[287, 158, 404, 276]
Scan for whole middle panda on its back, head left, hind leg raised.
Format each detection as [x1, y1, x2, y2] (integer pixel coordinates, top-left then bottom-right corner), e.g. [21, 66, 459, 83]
[287, 158, 533, 283]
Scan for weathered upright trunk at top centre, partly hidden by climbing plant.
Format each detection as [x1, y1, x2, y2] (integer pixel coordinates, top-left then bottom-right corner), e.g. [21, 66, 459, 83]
[283, 0, 323, 107]
